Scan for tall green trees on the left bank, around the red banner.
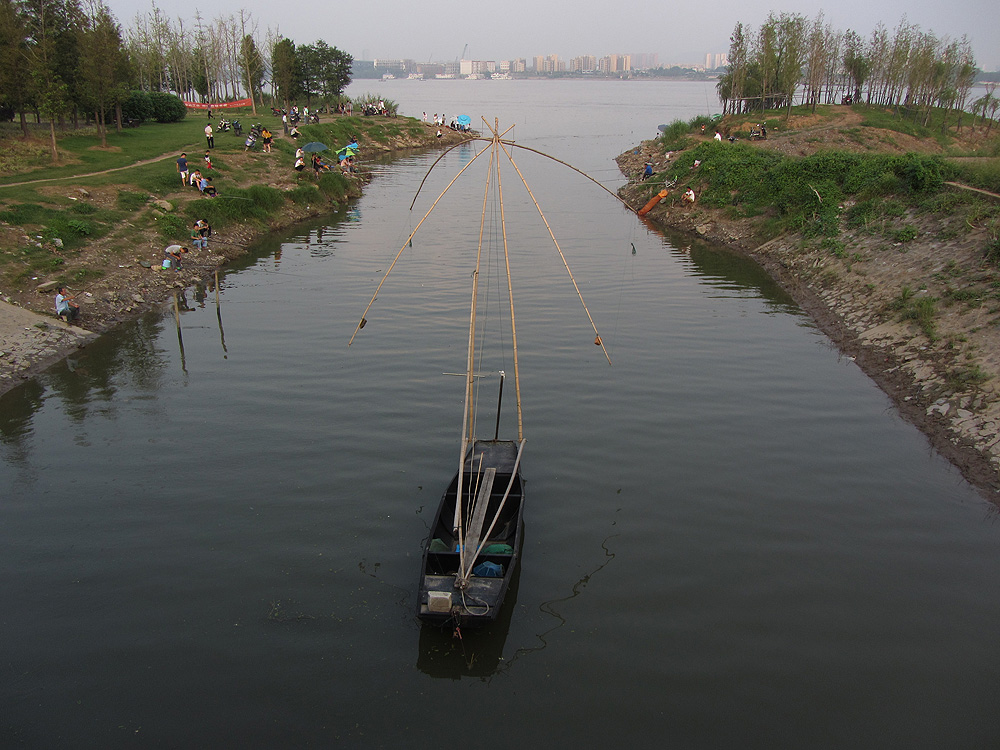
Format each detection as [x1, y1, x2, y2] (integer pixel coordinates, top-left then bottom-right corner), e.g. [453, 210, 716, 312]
[0, 0, 353, 160]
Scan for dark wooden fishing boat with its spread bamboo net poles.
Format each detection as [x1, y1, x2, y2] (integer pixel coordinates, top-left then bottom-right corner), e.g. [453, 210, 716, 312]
[349, 120, 618, 628]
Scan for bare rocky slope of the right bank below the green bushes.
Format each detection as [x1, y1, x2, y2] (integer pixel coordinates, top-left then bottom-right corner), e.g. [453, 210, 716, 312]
[618, 142, 1000, 502]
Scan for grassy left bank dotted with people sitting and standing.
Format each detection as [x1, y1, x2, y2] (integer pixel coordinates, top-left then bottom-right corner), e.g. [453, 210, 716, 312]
[0, 111, 472, 330]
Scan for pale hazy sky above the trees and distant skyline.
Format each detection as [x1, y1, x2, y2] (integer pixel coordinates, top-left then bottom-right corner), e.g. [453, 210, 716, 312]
[107, 0, 1000, 70]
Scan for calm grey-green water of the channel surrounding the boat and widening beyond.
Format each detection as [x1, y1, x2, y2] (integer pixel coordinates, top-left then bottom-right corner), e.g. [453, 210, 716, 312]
[0, 81, 1000, 748]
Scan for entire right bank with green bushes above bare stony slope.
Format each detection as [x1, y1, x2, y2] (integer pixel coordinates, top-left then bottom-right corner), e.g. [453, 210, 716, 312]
[618, 107, 1000, 491]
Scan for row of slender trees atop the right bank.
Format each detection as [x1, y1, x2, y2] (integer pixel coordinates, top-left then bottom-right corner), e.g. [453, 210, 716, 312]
[717, 11, 996, 129]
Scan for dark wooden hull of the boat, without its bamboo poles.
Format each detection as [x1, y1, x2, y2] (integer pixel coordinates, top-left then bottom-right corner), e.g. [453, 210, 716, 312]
[417, 440, 524, 627]
